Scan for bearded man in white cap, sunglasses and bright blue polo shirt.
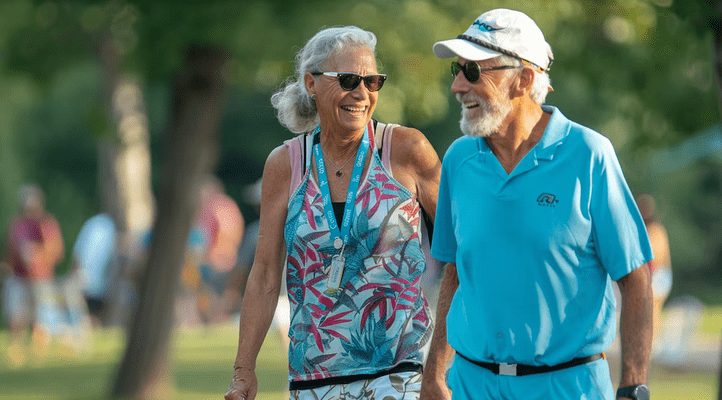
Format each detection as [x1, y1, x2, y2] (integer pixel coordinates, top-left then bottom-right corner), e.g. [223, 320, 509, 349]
[422, 9, 652, 400]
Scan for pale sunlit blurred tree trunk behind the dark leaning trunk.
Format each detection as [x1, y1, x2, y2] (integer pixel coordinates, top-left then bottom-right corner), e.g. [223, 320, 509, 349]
[97, 36, 153, 327]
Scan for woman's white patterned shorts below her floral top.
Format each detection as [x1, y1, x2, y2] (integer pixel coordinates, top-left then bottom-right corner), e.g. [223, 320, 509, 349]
[290, 372, 421, 400]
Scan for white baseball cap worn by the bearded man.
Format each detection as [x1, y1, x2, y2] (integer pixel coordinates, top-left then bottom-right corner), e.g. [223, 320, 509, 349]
[434, 8, 554, 71]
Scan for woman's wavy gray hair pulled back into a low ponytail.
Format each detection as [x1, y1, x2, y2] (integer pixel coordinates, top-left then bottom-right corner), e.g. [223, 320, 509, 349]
[271, 26, 376, 133]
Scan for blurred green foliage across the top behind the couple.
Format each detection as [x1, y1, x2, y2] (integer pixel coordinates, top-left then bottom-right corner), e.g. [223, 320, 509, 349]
[0, 0, 722, 288]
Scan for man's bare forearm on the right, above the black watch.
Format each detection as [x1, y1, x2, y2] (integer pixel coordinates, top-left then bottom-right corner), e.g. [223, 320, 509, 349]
[617, 265, 652, 398]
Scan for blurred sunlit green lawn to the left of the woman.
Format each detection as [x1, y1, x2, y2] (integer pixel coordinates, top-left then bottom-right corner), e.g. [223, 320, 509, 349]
[0, 325, 288, 400]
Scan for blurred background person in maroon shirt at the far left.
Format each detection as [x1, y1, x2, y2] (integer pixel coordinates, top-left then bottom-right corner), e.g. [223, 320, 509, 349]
[3, 184, 65, 365]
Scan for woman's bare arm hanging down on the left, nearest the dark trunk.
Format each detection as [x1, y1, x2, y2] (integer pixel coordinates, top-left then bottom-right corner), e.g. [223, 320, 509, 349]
[225, 146, 291, 400]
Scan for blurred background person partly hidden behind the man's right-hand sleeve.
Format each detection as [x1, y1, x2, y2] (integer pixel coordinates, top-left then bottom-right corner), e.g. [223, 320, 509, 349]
[636, 193, 672, 343]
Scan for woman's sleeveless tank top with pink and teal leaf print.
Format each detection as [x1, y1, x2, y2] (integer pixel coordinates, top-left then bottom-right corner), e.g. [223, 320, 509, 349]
[285, 123, 431, 381]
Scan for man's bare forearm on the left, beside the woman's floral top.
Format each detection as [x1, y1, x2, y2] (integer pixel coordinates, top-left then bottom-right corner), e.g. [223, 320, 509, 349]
[420, 263, 459, 400]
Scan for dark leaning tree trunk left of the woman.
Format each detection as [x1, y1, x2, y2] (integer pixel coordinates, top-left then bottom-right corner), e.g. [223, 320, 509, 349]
[113, 47, 227, 399]
